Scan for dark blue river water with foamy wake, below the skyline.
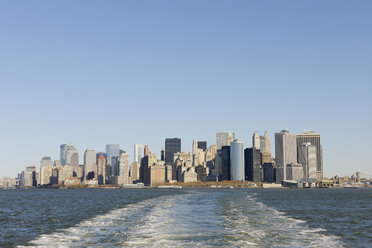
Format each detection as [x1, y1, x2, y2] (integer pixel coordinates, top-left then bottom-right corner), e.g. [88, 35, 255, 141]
[0, 189, 372, 248]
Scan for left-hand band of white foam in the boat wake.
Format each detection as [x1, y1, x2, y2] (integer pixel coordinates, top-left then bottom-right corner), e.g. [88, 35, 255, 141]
[18, 196, 185, 248]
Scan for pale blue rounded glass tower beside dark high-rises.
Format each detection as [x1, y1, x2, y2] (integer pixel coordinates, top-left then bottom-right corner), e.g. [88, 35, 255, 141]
[230, 139, 244, 181]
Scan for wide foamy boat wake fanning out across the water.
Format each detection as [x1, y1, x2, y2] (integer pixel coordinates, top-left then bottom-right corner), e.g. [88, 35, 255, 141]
[21, 191, 343, 247]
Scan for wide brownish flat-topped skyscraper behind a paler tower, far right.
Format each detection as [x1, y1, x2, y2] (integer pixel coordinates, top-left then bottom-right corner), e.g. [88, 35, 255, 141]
[296, 131, 323, 180]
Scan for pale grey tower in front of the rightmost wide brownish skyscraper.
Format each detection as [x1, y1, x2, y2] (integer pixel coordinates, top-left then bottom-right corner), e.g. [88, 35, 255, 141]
[297, 143, 317, 179]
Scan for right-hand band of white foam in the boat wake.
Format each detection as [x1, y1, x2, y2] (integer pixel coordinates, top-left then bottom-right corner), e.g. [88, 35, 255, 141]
[219, 195, 344, 247]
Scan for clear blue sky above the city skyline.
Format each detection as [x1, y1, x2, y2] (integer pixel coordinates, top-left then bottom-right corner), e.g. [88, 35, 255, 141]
[0, 0, 372, 178]
